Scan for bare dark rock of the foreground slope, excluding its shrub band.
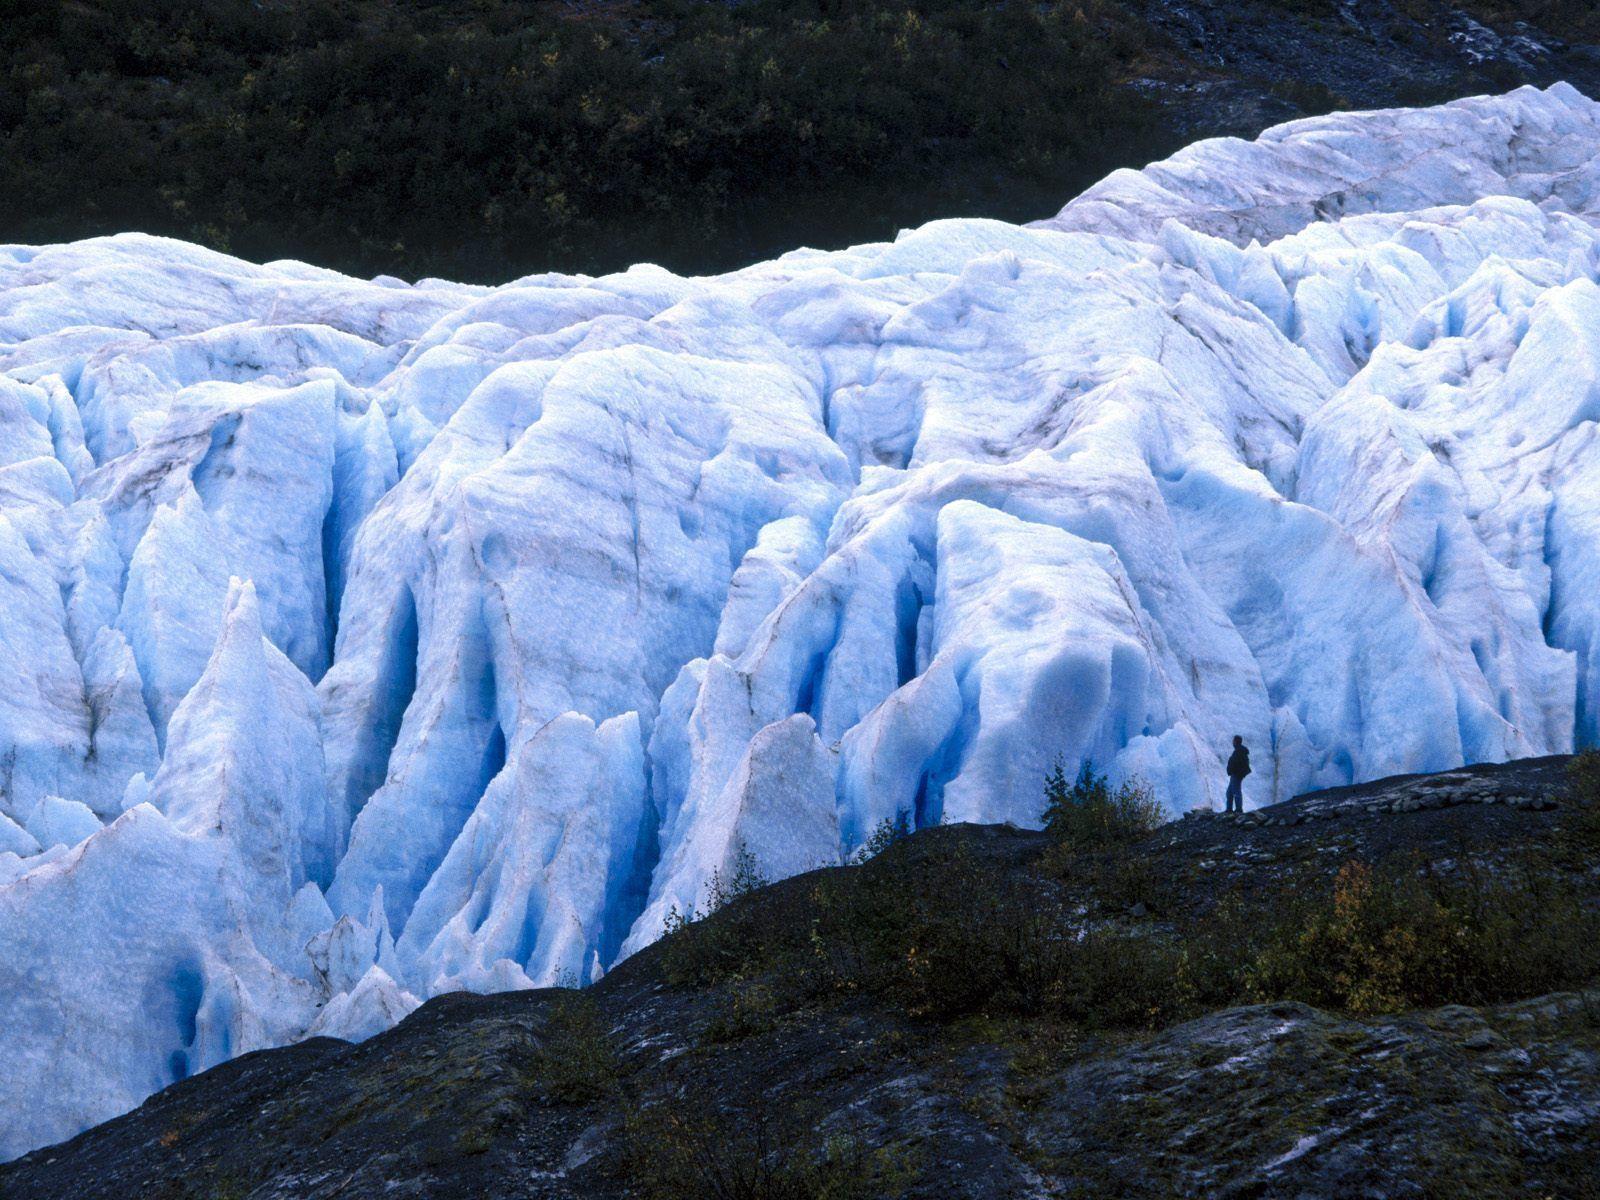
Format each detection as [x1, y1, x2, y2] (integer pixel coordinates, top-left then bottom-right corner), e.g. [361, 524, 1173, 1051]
[0, 760, 1600, 1200]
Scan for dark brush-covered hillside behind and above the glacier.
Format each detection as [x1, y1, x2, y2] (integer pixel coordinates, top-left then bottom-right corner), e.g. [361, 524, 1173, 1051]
[0, 0, 1600, 283]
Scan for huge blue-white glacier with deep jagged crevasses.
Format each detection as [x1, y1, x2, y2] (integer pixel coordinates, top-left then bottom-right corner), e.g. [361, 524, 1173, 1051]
[0, 85, 1600, 1157]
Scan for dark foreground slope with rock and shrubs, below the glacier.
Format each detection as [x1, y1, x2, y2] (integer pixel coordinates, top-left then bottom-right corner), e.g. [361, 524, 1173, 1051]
[0, 760, 1600, 1200]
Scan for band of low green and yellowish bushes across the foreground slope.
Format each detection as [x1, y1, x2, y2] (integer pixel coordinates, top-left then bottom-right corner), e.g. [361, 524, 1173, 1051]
[652, 758, 1600, 1040]
